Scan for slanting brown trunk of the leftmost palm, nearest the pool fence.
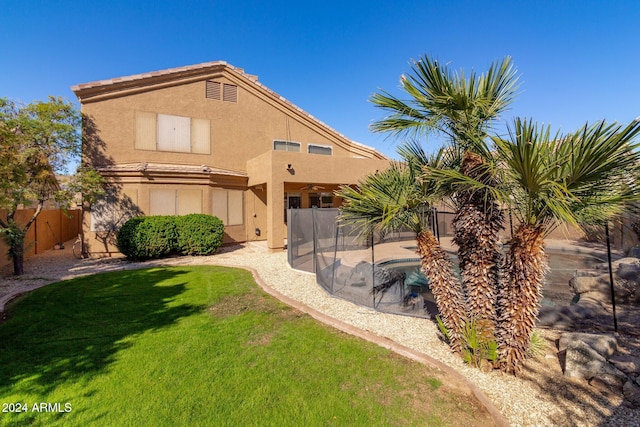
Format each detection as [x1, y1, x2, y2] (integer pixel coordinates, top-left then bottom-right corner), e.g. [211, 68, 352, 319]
[416, 231, 467, 351]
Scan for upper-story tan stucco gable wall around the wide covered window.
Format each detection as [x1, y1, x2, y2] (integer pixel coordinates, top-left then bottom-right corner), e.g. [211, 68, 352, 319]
[82, 79, 372, 170]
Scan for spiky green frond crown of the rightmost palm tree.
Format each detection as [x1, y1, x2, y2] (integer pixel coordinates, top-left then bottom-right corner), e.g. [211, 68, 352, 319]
[492, 119, 640, 225]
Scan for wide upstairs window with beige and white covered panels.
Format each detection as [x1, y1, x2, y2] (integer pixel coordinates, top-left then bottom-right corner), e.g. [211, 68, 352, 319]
[135, 111, 211, 154]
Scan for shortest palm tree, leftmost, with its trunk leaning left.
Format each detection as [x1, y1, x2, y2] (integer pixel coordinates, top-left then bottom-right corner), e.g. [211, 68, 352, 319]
[336, 149, 466, 351]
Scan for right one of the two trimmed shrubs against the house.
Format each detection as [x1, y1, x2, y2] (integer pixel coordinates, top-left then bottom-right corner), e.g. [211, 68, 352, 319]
[176, 214, 224, 255]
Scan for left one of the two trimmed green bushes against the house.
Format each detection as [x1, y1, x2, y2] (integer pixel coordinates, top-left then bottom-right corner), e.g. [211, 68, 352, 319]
[116, 216, 178, 260]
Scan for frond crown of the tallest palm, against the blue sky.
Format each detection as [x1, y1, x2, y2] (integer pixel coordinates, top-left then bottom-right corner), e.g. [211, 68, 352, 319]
[369, 55, 518, 148]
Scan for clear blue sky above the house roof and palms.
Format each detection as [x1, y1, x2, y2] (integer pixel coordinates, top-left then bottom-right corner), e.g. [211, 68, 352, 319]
[0, 0, 640, 156]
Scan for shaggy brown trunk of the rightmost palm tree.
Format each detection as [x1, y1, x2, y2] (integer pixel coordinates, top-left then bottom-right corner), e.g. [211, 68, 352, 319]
[496, 224, 548, 373]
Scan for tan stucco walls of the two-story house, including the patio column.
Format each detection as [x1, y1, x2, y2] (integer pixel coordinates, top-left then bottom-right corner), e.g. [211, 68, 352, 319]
[76, 66, 388, 252]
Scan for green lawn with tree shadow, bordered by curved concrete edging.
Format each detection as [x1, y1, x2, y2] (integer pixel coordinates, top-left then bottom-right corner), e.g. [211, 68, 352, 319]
[0, 267, 491, 426]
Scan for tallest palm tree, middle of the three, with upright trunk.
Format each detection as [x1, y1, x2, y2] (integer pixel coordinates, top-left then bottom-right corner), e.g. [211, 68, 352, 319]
[371, 56, 518, 330]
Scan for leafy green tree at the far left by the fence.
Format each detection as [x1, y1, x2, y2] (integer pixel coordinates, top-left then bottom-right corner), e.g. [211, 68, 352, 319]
[0, 97, 102, 275]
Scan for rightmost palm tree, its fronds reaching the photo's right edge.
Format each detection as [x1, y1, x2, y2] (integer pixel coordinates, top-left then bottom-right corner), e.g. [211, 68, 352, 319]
[492, 119, 640, 372]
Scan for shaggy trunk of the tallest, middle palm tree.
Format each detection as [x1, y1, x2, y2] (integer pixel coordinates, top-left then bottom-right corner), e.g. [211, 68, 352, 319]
[453, 151, 504, 334]
